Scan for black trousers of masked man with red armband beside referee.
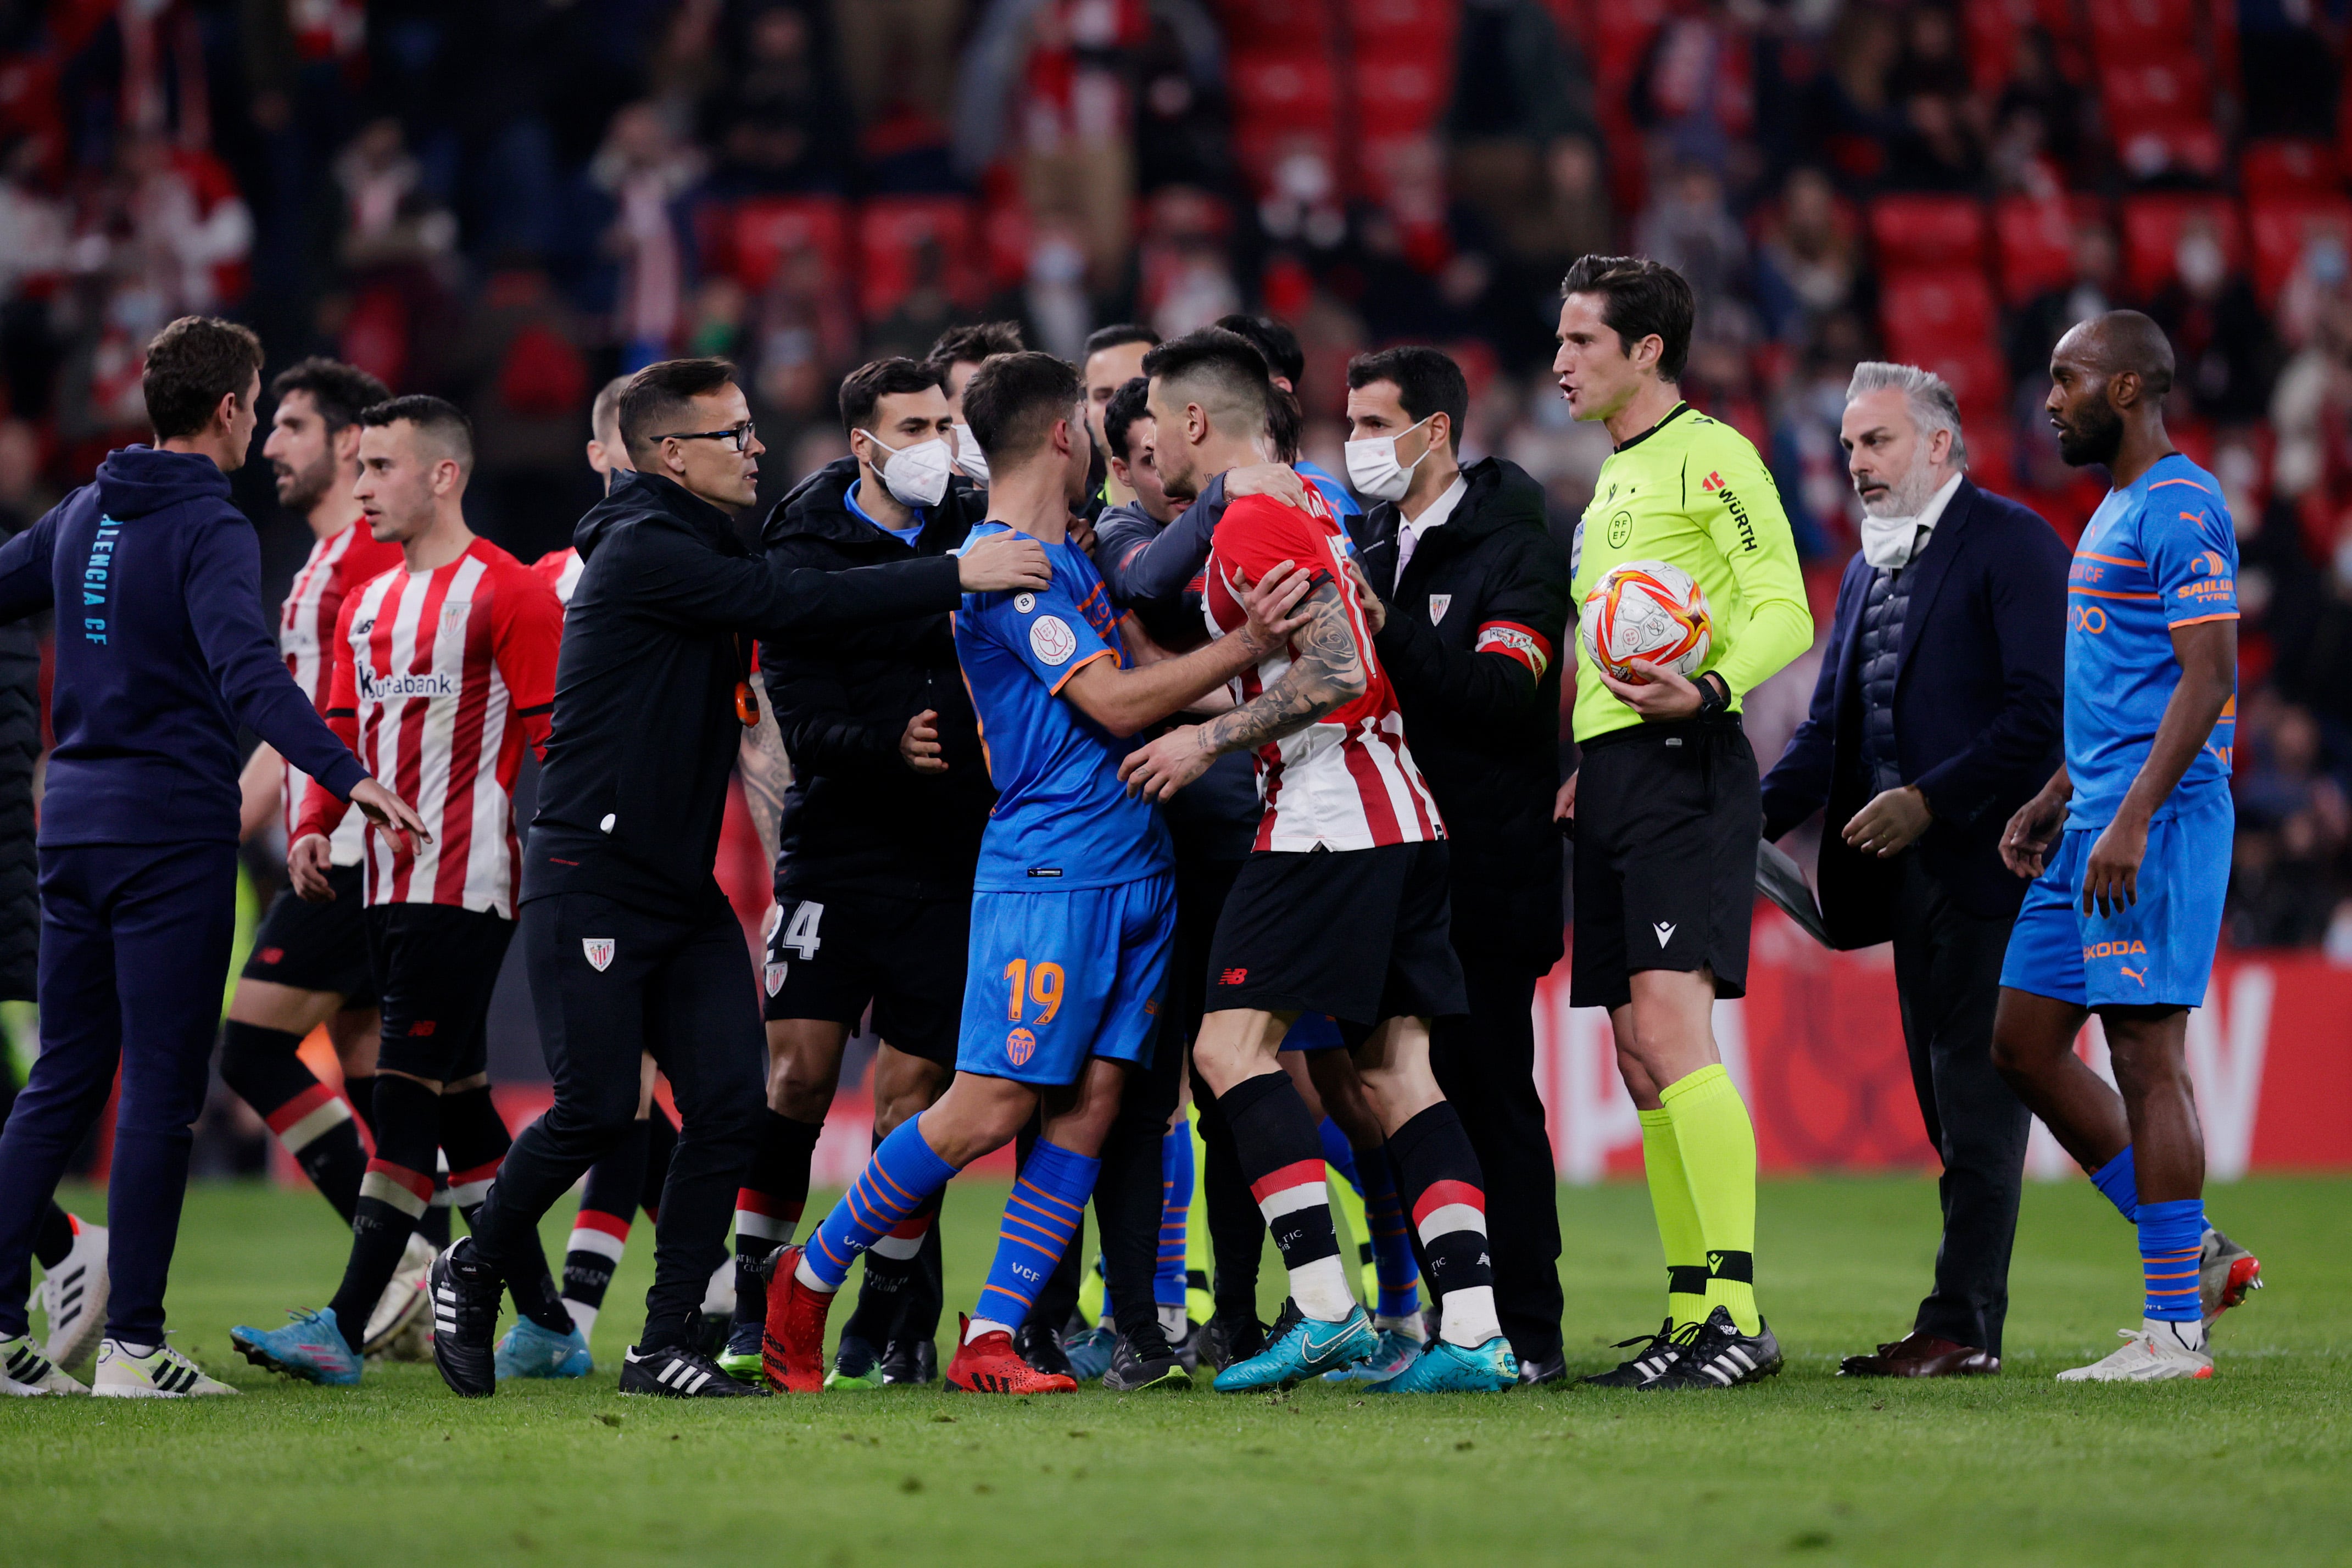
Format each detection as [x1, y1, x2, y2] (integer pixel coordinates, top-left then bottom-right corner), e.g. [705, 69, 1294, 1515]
[1430, 945, 1562, 1366]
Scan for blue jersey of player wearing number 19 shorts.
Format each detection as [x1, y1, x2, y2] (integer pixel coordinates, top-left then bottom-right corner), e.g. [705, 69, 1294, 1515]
[955, 522, 1176, 894]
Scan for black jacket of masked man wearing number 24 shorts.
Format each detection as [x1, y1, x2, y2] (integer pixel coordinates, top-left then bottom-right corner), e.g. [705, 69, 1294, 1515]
[760, 459, 997, 898]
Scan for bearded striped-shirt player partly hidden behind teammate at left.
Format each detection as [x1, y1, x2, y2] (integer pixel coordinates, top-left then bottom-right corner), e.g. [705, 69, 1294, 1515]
[221, 360, 416, 1349]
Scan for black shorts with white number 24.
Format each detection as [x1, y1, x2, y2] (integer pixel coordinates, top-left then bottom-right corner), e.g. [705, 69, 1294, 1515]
[760, 891, 971, 1067]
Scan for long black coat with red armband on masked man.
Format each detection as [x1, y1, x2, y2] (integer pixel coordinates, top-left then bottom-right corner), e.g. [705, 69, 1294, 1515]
[1350, 459, 1569, 969]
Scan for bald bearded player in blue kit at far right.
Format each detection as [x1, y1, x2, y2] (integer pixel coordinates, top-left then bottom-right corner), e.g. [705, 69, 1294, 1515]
[1992, 310, 2262, 1382]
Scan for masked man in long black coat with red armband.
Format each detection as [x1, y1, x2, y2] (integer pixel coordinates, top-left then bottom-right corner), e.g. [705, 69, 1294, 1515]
[1348, 348, 1569, 1385]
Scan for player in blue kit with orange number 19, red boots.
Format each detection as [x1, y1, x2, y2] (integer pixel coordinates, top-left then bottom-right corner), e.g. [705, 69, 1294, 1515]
[765, 353, 1301, 1394]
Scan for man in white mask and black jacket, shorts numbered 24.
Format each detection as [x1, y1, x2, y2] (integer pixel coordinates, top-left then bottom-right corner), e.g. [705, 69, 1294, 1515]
[720, 360, 995, 1387]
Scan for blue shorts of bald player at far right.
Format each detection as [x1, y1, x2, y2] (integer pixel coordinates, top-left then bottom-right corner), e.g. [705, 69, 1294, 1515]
[2002, 790, 2237, 1008]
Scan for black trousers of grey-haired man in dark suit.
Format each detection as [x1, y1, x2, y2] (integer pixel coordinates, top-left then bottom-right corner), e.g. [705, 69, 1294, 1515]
[1893, 853, 2032, 1354]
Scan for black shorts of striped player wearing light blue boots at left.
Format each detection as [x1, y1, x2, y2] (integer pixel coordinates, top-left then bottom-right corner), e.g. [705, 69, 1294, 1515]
[367, 903, 515, 1084]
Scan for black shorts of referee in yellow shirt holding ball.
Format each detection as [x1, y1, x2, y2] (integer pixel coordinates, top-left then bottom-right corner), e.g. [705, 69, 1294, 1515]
[1569, 719, 1764, 1008]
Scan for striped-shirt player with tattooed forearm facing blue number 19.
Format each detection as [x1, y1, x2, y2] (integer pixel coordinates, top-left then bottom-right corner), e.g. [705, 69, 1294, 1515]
[1119, 327, 1519, 1394]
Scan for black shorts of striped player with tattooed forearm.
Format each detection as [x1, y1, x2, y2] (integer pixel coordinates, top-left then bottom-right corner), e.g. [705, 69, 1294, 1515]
[1207, 839, 1470, 1032]
